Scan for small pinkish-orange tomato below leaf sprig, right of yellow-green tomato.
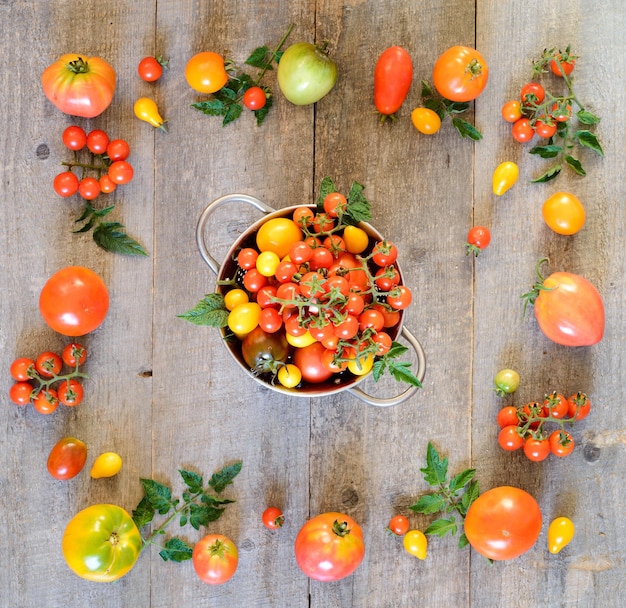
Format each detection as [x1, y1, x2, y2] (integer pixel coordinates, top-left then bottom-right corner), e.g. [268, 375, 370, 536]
[191, 534, 239, 585]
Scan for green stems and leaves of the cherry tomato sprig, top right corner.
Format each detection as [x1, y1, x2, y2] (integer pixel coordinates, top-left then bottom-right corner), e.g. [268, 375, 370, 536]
[523, 45, 604, 183]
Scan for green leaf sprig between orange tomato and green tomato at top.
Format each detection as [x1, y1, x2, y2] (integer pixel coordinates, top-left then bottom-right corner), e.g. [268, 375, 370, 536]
[191, 23, 295, 127]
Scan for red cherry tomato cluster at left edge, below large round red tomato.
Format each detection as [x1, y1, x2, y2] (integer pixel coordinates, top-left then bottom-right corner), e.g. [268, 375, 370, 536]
[9, 342, 87, 414]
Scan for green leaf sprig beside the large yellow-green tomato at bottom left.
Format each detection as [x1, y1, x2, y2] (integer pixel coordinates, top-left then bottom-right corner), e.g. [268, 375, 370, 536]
[132, 461, 242, 562]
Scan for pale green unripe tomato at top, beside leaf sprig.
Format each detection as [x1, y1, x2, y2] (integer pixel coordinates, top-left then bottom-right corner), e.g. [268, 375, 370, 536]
[277, 42, 337, 106]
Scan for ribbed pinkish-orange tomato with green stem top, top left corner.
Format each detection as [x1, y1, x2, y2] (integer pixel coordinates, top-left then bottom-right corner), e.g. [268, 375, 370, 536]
[41, 53, 115, 118]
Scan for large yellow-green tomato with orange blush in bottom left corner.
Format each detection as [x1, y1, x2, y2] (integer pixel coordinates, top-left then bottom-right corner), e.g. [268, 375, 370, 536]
[62, 504, 143, 583]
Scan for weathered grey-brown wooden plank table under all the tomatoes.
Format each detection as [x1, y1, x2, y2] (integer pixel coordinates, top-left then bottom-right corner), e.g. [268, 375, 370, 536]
[0, 0, 626, 608]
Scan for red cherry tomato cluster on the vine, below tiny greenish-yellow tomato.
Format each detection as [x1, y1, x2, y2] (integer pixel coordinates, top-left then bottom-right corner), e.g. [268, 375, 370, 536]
[497, 391, 591, 462]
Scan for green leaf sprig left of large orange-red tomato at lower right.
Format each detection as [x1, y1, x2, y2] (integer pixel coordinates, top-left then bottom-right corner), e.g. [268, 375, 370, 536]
[409, 442, 480, 548]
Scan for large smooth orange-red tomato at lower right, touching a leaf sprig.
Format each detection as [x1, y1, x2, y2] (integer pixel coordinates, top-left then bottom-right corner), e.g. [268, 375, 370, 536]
[464, 486, 541, 560]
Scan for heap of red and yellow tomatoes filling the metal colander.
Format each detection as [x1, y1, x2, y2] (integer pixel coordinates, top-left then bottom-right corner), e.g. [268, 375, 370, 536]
[224, 192, 412, 388]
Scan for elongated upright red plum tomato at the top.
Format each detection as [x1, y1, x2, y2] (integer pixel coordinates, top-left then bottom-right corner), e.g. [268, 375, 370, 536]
[374, 46, 413, 118]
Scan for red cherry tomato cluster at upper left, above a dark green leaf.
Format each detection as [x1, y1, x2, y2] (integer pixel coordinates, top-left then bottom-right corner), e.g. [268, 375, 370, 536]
[53, 125, 134, 201]
